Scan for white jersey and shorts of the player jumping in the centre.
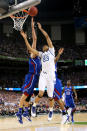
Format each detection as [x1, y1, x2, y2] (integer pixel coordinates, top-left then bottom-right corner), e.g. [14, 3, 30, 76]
[39, 48, 55, 97]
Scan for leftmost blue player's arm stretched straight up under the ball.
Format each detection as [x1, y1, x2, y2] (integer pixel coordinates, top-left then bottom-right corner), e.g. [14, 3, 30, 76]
[31, 17, 37, 49]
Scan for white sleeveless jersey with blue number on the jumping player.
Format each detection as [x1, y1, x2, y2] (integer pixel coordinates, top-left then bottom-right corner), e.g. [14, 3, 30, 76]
[39, 48, 55, 75]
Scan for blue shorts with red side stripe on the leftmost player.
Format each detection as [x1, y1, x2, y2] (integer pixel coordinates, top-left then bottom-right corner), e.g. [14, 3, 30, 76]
[22, 73, 39, 96]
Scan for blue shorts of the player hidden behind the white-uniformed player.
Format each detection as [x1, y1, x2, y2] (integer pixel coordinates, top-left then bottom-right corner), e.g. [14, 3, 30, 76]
[54, 78, 62, 100]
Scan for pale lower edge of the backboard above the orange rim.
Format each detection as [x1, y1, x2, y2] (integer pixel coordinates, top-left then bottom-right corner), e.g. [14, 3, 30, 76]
[0, 0, 41, 19]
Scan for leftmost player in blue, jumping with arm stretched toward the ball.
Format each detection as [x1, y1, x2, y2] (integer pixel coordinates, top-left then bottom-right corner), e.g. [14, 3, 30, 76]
[16, 18, 41, 124]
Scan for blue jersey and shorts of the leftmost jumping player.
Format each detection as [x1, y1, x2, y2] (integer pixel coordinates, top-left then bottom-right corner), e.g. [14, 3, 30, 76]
[22, 57, 41, 96]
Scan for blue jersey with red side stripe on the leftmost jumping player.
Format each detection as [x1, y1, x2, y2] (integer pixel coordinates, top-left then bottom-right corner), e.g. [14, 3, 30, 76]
[29, 56, 41, 75]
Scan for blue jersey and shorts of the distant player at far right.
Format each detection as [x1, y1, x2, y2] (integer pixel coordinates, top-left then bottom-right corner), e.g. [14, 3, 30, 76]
[64, 86, 75, 109]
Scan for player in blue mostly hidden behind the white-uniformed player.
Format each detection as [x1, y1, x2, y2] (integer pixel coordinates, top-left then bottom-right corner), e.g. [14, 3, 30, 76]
[54, 48, 68, 124]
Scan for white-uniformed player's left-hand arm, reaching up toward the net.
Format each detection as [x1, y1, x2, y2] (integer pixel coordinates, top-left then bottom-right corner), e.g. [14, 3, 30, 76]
[20, 31, 39, 56]
